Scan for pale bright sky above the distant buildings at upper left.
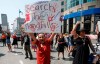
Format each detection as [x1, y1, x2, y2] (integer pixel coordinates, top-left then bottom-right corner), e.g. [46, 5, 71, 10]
[0, 0, 48, 29]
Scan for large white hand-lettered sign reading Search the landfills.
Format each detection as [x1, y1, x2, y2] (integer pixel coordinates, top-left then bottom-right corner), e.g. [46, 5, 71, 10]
[23, 1, 61, 33]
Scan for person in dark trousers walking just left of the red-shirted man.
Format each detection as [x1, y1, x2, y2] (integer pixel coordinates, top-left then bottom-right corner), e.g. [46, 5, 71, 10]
[24, 33, 33, 60]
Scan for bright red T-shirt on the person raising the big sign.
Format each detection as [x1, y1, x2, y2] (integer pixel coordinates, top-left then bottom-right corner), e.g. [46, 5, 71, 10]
[36, 39, 51, 64]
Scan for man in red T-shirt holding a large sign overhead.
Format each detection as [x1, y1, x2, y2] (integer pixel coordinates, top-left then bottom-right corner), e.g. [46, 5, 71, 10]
[29, 33, 55, 64]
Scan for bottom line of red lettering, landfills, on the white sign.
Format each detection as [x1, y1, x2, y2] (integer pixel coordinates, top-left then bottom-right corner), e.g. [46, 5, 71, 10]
[26, 21, 58, 32]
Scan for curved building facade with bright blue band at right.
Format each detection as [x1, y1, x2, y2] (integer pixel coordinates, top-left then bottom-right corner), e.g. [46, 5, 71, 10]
[63, 0, 100, 34]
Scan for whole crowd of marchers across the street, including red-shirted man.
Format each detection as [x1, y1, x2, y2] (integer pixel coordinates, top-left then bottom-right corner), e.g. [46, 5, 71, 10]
[1, 22, 100, 64]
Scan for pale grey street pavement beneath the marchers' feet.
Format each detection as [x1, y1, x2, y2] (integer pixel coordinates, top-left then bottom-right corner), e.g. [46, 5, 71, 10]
[0, 38, 72, 64]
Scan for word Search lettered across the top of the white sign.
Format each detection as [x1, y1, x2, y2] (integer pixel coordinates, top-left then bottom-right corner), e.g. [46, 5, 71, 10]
[25, 3, 57, 13]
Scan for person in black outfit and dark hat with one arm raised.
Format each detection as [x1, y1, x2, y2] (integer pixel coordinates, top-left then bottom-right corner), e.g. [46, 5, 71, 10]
[72, 22, 95, 64]
